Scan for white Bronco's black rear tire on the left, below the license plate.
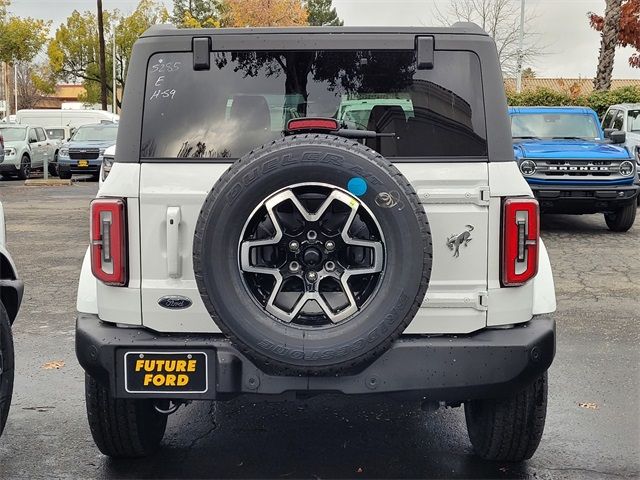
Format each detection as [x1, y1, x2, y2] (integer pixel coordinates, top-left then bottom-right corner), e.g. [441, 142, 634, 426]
[85, 375, 167, 458]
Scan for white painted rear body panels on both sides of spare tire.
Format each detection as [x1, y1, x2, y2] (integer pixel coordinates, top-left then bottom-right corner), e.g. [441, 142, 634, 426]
[78, 158, 555, 334]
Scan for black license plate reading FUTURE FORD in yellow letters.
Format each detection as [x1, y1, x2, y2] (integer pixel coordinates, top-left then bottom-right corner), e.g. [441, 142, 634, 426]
[124, 352, 209, 393]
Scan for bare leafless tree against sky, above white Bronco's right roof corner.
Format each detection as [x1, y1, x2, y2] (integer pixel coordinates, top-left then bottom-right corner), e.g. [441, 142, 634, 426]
[434, 0, 544, 77]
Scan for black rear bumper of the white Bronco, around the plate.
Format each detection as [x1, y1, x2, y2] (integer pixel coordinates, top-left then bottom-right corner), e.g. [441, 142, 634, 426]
[76, 313, 555, 402]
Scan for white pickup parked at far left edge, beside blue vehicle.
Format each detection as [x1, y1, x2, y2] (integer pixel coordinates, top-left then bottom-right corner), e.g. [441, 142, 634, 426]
[0, 124, 59, 180]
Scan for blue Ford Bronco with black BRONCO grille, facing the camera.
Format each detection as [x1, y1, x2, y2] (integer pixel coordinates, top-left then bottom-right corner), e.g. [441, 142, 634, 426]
[509, 107, 640, 232]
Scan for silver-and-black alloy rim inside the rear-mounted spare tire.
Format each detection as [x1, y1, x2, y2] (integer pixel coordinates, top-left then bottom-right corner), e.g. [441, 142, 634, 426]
[239, 184, 384, 325]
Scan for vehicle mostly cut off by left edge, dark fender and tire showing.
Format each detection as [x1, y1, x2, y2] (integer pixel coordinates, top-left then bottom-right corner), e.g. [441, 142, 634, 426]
[0, 197, 24, 435]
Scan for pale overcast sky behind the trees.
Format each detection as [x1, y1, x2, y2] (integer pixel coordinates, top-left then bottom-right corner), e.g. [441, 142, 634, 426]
[9, 0, 640, 79]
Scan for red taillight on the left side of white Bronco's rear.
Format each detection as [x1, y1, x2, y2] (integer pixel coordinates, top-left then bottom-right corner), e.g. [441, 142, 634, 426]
[91, 198, 127, 287]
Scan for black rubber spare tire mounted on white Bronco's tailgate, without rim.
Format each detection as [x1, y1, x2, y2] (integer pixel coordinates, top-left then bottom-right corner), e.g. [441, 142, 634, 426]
[193, 135, 432, 375]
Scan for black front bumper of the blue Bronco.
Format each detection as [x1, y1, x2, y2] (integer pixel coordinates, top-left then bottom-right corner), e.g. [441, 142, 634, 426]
[530, 184, 640, 213]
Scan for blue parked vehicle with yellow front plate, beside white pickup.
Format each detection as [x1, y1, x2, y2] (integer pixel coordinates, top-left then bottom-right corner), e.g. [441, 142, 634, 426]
[58, 123, 118, 180]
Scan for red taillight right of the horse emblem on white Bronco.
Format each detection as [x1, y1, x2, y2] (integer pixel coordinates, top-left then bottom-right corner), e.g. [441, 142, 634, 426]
[502, 198, 540, 287]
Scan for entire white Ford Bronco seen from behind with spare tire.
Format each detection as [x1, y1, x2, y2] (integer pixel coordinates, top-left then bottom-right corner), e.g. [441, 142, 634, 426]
[76, 24, 555, 461]
